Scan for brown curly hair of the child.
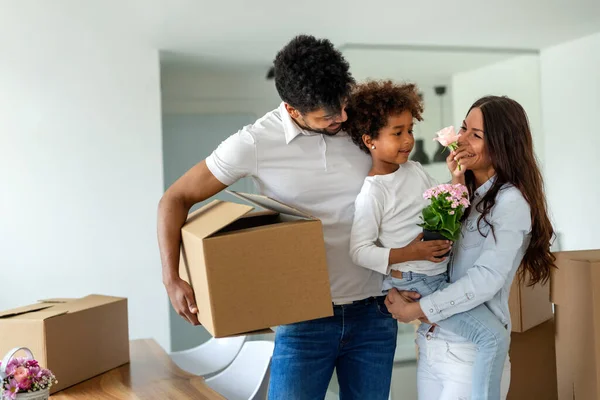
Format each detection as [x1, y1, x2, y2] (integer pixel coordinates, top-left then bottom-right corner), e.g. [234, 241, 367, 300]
[343, 81, 423, 154]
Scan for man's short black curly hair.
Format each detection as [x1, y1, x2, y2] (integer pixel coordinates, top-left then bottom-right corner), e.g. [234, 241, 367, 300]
[274, 35, 354, 114]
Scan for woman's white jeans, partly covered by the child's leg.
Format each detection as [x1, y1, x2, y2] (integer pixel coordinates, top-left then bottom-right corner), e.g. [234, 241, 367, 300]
[417, 335, 510, 400]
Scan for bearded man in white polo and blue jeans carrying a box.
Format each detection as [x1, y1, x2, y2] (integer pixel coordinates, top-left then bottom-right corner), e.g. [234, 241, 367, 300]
[158, 36, 397, 400]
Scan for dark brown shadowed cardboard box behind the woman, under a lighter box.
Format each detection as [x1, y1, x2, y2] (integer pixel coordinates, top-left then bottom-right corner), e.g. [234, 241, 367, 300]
[507, 319, 558, 400]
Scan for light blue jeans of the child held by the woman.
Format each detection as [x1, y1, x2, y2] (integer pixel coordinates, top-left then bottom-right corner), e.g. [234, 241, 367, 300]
[391, 272, 510, 400]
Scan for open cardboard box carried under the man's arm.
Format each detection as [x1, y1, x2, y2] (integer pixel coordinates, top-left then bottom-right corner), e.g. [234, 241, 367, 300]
[180, 192, 333, 338]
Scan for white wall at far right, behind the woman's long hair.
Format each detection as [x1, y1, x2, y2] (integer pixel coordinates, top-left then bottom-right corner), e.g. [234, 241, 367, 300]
[540, 32, 600, 250]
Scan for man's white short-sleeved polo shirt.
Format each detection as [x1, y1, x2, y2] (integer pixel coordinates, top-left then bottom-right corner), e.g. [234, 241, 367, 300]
[206, 103, 384, 302]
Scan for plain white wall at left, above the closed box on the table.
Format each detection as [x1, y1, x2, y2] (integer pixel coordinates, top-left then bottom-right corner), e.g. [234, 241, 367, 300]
[0, 1, 169, 346]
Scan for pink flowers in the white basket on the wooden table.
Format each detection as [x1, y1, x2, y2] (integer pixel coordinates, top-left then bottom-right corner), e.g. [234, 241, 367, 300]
[0, 358, 58, 400]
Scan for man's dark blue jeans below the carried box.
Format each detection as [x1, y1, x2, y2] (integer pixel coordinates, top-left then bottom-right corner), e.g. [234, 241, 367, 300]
[269, 297, 398, 400]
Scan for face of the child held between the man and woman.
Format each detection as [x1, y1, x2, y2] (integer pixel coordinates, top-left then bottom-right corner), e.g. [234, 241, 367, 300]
[363, 110, 415, 165]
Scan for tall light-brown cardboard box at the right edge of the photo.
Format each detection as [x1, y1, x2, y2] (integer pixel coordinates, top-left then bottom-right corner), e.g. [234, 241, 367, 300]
[551, 250, 600, 400]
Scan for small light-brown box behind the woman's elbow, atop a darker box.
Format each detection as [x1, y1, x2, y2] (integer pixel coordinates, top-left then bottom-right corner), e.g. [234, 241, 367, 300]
[508, 270, 553, 332]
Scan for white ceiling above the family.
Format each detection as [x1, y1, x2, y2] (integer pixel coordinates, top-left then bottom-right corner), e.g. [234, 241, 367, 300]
[151, 0, 600, 66]
